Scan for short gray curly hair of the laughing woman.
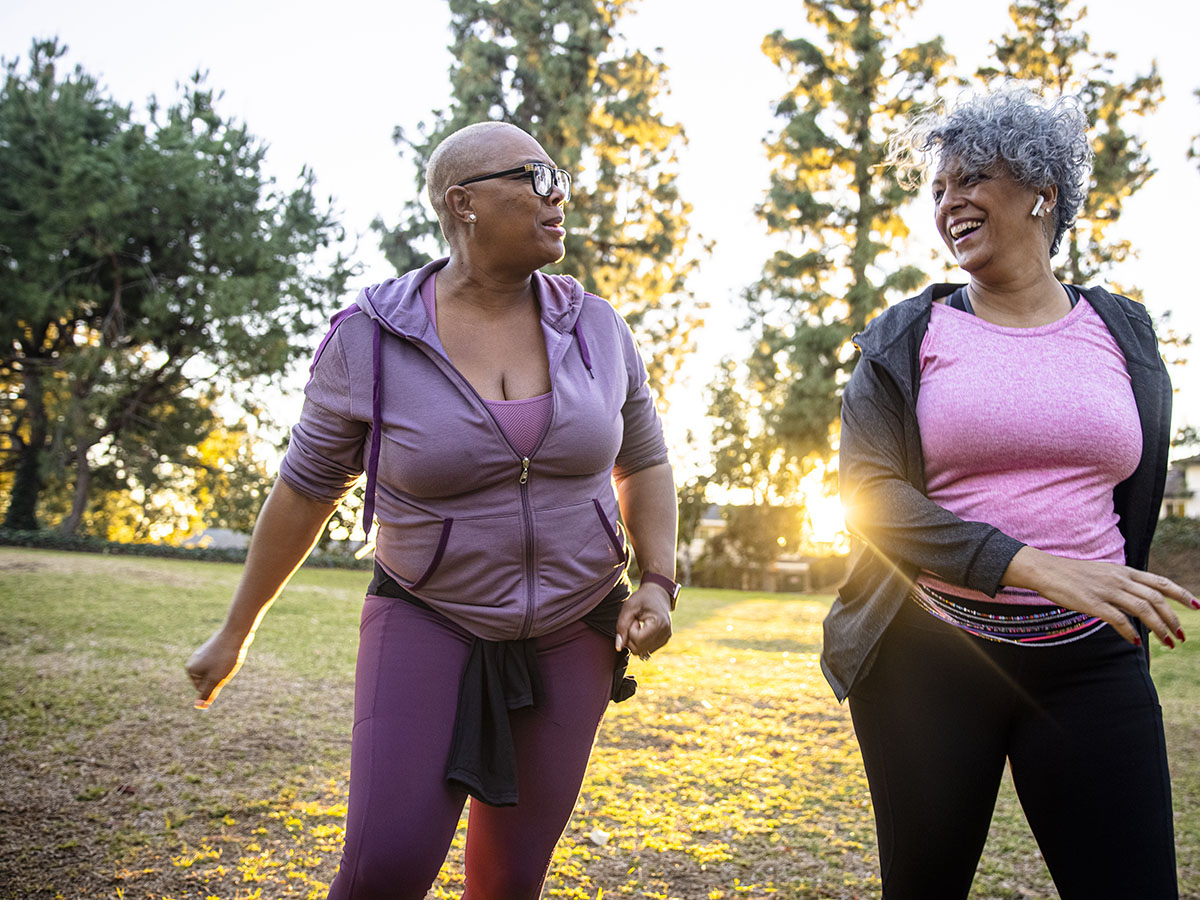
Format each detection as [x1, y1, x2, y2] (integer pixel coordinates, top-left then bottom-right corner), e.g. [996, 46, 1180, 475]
[888, 84, 1092, 256]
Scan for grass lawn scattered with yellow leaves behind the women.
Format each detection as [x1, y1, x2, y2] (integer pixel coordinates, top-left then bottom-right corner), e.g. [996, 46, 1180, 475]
[0, 547, 1200, 900]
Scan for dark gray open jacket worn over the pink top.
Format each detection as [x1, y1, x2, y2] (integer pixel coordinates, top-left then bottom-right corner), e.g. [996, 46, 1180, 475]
[821, 284, 1171, 701]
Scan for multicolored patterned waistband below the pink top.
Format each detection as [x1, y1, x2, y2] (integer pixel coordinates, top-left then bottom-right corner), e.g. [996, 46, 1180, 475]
[908, 584, 1104, 647]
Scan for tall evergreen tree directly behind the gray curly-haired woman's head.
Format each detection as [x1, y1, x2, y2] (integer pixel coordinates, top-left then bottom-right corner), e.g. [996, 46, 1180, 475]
[978, 0, 1163, 296]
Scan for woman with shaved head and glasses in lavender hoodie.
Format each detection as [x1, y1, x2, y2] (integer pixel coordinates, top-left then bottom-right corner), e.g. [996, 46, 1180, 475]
[188, 122, 678, 900]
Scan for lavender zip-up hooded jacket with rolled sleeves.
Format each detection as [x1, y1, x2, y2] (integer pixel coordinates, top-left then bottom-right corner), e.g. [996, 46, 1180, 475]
[280, 259, 667, 641]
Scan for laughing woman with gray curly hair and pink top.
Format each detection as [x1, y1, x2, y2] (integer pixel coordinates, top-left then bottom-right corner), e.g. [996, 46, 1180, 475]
[822, 86, 1200, 900]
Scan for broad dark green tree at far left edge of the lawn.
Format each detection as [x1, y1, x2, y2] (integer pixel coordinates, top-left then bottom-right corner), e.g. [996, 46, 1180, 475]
[0, 41, 348, 533]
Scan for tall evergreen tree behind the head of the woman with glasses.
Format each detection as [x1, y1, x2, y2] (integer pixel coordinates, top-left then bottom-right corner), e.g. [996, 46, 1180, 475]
[376, 0, 698, 384]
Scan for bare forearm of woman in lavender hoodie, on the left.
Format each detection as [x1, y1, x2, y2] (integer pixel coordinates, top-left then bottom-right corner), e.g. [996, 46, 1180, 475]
[222, 480, 337, 637]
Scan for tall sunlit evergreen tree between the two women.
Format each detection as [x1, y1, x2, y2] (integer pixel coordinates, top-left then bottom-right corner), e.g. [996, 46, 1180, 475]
[715, 0, 949, 493]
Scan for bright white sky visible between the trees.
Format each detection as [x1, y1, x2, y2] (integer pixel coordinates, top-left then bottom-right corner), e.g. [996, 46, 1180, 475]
[7, 0, 1200, 465]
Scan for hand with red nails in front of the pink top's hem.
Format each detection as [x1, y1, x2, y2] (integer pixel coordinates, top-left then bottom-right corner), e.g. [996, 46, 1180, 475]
[1002, 546, 1200, 647]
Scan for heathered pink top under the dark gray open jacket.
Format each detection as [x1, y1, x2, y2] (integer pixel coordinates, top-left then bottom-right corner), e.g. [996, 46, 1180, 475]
[917, 299, 1141, 604]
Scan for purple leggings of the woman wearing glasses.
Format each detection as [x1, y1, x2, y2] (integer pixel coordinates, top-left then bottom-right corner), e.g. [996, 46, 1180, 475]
[329, 595, 616, 900]
